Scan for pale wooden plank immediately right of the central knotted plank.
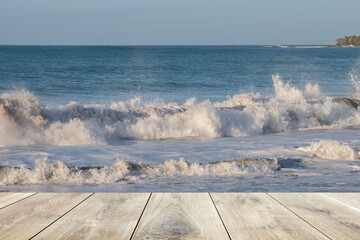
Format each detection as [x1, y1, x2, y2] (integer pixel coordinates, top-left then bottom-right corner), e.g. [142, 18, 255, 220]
[211, 193, 328, 239]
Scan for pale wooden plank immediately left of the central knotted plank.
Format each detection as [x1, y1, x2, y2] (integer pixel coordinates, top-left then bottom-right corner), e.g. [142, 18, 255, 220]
[34, 193, 150, 239]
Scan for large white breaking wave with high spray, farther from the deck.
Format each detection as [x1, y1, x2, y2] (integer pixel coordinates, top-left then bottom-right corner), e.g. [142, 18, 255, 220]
[0, 75, 360, 146]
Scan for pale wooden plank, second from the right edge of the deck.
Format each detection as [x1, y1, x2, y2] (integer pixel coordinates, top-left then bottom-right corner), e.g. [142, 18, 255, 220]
[270, 193, 360, 239]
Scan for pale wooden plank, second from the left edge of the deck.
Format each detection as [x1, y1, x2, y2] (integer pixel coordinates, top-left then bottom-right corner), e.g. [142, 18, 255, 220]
[0, 193, 91, 239]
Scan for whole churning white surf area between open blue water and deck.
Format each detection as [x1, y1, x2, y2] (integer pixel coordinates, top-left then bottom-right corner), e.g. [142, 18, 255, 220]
[0, 75, 360, 191]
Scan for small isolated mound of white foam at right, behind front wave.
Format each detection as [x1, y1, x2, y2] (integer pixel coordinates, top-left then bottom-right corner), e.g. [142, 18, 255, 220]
[304, 140, 359, 160]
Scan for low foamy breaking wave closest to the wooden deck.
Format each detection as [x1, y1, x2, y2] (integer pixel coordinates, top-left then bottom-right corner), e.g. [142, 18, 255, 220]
[0, 158, 279, 185]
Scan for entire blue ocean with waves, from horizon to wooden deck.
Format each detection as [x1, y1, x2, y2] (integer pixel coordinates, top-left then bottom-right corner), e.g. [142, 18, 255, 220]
[0, 45, 360, 192]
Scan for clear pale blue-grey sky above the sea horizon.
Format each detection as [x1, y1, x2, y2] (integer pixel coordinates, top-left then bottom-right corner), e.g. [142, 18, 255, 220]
[0, 0, 360, 45]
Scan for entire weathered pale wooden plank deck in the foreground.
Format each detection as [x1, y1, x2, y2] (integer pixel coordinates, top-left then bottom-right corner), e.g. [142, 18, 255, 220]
[0, 193, 360, 239]
